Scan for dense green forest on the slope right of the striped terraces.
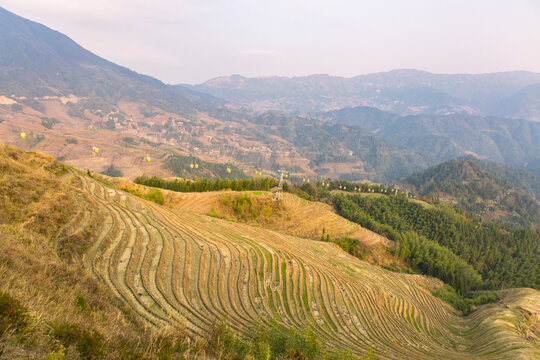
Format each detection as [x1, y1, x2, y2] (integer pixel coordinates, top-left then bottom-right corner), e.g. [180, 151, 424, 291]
[333, 194, 540, 295]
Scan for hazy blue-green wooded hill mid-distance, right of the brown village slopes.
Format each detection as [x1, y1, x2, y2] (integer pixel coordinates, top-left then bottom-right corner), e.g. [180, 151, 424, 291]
[250, 113, 429, 182]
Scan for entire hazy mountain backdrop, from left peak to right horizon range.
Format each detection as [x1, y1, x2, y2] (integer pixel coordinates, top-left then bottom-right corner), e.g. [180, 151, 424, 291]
[0, 8, 540, 186]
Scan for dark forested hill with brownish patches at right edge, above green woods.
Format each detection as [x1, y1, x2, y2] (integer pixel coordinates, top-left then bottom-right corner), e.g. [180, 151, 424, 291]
[402, 159, 540, 229]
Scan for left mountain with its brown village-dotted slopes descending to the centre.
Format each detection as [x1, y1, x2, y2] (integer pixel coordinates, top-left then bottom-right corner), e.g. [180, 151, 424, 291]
[0, 8, 429, 181]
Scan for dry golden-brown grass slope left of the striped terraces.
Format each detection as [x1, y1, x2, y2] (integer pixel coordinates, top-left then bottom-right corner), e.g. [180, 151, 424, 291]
[0, 144, 196, 359]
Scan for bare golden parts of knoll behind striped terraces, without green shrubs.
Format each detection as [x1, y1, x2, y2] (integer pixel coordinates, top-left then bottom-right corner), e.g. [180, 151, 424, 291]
[113, 178, 389, 245]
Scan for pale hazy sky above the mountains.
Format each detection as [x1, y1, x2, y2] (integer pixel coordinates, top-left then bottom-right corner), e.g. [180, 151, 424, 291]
[0, 0, 540, 83]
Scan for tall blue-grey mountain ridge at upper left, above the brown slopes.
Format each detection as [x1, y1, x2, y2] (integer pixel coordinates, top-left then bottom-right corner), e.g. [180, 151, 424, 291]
[0, 8, 224, 116]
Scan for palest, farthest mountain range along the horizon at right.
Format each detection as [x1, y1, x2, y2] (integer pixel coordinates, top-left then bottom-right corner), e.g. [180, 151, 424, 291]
[182, 69, 540, 121]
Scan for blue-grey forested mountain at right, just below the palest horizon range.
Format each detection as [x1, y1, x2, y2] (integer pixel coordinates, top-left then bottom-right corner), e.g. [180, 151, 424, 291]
[317, 107, 540, 167]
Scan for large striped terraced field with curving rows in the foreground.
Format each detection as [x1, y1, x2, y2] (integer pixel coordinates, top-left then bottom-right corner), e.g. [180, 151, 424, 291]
[80, 176, 540, 359]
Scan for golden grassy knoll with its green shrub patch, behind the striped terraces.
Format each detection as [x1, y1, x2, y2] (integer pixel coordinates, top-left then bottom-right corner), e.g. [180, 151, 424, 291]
[101, 174, 398, 267]
